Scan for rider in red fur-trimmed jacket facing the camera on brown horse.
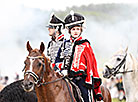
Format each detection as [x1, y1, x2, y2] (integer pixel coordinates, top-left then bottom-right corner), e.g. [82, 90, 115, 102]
[55, 11, 103, 102]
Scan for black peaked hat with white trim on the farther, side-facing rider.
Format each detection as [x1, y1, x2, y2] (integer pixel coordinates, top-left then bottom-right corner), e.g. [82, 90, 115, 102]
[46, 14, 64, 28]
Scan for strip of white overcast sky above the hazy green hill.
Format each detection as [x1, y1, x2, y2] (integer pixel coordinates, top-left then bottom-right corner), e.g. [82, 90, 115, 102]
[0, 0, 138, 10]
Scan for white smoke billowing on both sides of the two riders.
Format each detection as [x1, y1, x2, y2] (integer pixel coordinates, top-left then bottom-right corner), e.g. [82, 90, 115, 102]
[0, 0, 138, 83]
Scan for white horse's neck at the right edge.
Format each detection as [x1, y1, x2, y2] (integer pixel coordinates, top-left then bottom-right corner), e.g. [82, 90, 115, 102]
[123, 53, 138, 102]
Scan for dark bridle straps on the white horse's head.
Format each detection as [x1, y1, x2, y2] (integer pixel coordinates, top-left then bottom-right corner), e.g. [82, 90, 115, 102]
[106, 53, 133, 76]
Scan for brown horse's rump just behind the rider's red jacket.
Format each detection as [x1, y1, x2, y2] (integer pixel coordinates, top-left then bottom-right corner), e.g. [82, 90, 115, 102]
[101, 85, 112, 102]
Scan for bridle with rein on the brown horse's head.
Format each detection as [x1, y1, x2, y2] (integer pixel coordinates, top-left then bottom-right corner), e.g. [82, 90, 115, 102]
[23, 56, 66, 87]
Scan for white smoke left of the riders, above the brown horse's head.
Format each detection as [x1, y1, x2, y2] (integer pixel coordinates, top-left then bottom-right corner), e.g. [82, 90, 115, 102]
[0, 0, 50, 83]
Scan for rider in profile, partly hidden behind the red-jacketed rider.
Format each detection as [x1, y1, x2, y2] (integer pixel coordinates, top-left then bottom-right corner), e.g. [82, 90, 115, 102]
[46, 14, 64, 68]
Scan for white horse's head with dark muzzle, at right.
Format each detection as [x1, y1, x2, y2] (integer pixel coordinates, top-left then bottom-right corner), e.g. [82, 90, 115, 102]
[103, 47, 128, 78]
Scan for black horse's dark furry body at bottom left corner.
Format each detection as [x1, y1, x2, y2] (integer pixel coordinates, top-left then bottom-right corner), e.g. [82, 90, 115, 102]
[0, 80, 37, 102]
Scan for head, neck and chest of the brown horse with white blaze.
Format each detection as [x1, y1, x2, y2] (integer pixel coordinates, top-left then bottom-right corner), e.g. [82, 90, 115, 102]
[23, 41, 75, 102]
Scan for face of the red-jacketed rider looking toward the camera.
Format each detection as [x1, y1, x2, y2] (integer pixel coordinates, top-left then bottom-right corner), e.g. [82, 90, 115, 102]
[70, 26, 82, 38]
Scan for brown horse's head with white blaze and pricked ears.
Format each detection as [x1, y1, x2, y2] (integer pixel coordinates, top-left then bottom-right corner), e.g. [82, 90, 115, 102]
[23, 41, 47, 92]
